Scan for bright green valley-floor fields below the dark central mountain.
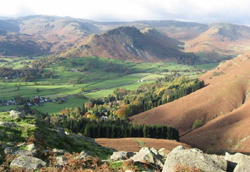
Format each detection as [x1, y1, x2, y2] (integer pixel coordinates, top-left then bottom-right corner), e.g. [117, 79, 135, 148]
[0, 57, 204, 114]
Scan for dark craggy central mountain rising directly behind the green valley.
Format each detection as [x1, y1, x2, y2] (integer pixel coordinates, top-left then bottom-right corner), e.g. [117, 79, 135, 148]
[60, 27, 195, 63]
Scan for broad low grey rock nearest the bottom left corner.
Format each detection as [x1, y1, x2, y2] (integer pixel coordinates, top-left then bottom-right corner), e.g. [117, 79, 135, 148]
[10, 155, 46, 170]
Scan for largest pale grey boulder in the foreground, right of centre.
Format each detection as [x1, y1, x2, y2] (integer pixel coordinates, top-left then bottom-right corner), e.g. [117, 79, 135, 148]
[163, 146, 227, 172]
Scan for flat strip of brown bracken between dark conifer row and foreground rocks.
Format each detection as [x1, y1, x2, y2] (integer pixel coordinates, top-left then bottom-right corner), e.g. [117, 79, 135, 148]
[95, 138, 191, 153]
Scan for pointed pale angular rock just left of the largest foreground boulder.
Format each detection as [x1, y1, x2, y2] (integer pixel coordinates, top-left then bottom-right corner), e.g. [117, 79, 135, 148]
[130, 147, 163, 167]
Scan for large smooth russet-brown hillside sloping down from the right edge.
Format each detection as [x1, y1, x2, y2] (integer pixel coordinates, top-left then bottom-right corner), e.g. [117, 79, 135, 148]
[131, 54, 250, 153]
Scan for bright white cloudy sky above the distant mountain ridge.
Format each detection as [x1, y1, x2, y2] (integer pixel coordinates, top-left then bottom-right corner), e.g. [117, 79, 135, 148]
[0, 0, 250, 25]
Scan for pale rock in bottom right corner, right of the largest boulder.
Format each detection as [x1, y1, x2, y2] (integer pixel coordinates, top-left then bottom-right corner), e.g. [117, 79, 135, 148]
[225, 152, 250, 172]
